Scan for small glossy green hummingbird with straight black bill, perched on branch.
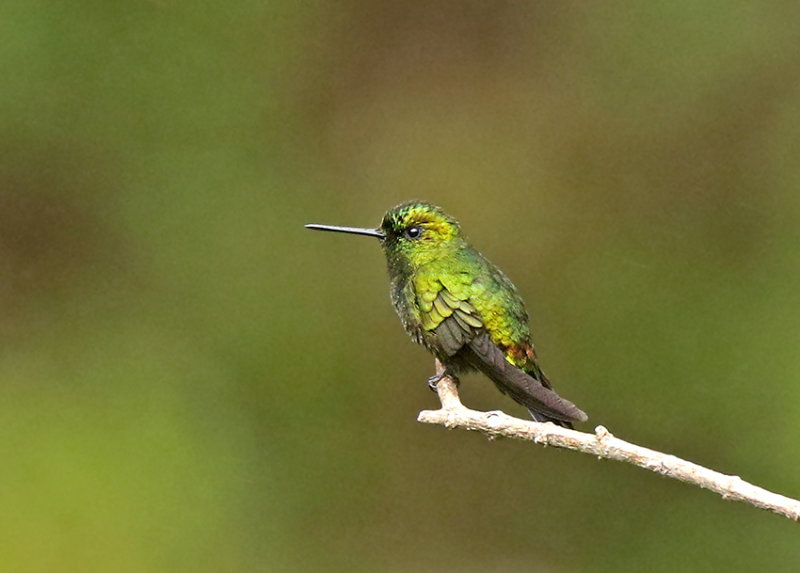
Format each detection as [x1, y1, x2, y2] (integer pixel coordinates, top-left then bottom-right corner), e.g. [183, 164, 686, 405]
[306, 201, 588, 427]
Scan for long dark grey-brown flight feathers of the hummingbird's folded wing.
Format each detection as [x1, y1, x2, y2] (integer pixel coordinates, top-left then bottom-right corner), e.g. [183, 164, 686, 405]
[463, 334, 589, 427]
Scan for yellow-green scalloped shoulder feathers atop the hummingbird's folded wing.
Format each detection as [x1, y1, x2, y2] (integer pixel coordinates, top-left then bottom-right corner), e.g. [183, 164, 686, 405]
[416, 280, 483, 356]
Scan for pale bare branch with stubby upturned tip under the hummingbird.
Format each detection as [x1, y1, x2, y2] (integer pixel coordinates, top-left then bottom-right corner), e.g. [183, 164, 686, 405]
[417, 361, 800, 521]
